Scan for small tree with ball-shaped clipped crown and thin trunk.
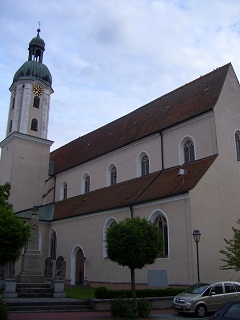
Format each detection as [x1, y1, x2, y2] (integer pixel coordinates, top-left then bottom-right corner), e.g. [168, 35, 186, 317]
[106, 217, 162, 316]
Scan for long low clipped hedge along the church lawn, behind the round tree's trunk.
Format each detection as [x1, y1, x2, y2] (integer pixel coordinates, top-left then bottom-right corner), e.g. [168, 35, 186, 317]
[95, 287, 185, 299]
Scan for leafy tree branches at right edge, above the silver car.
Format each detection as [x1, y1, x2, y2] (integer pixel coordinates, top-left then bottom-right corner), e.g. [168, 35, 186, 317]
[220, 219, 240, 271]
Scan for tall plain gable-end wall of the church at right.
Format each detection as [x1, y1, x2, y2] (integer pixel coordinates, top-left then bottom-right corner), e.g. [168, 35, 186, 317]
[188, 65, 240, 280]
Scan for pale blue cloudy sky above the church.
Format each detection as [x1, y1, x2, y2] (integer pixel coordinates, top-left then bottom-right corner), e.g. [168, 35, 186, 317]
[0, 0, 240, 150]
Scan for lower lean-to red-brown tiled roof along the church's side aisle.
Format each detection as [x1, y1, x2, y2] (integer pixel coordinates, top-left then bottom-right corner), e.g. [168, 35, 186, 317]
[53, 156, 217, 220]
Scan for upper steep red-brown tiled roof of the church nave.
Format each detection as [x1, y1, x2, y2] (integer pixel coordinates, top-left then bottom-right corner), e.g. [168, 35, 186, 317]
[51, 63, 231, 173]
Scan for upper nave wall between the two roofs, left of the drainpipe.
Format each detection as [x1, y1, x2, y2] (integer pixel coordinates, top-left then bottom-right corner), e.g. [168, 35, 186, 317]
[56, 135, 162, 201]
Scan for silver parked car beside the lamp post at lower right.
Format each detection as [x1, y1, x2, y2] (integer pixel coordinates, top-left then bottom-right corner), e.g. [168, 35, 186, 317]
[172, 281, 240, 317]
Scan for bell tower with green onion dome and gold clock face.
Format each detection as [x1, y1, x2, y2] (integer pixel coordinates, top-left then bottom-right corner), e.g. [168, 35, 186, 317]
[0, 29, 53, 211]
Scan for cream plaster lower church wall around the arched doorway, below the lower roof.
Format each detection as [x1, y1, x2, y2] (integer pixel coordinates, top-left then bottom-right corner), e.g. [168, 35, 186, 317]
[51, 197, 192, 284]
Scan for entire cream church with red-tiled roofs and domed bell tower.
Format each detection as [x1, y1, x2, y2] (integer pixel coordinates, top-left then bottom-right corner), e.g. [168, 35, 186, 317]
[0, 29, 240, 286]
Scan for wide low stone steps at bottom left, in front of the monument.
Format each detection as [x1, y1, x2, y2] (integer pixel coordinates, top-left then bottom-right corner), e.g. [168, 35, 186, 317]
[6, 298, 93, 313]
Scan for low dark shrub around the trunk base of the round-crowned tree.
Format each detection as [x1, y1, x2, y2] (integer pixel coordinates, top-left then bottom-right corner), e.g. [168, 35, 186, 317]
[111, 299, 151, 319]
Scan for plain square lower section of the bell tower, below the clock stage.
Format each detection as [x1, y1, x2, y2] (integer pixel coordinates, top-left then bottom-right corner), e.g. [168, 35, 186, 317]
[0, 133, 51, 211]
